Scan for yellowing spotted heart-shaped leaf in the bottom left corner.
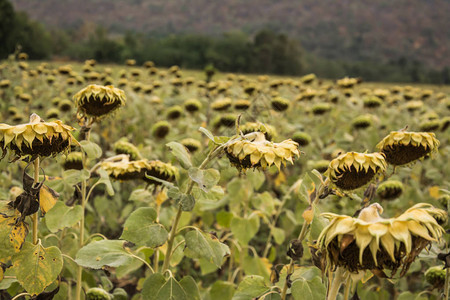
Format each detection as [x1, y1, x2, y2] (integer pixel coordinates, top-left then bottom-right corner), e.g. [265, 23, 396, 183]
[12, 242, 63, 295]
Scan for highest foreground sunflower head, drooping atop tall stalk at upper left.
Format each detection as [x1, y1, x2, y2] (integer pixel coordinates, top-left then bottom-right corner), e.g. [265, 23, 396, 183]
[73, 84, 126, 118]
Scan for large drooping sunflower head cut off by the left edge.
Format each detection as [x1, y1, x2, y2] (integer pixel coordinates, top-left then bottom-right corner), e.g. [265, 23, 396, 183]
[0, 114, 78, 158]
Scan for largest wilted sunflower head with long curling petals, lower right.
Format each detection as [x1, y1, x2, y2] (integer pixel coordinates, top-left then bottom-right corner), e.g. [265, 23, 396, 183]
[316, 203, 447, 277]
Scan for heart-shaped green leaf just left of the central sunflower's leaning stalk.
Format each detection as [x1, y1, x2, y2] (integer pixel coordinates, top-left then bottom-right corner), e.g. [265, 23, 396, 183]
[120, 207, 168, 248]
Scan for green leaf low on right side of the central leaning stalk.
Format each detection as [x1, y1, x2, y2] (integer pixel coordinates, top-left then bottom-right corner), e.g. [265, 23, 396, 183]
[185, 230, 230, 267]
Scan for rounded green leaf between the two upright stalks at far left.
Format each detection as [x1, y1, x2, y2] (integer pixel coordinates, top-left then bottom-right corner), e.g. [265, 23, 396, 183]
[45, 201, 83, 232]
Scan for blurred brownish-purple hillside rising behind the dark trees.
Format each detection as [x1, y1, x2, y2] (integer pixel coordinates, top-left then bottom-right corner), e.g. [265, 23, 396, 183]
[12, 0, 450, 68]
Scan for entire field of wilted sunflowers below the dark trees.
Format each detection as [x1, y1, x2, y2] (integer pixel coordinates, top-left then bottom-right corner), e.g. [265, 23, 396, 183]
[0, 53, 450, 300]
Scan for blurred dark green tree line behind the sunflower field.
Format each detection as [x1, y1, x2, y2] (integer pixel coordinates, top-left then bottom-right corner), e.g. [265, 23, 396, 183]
[0, 0, 450, 84]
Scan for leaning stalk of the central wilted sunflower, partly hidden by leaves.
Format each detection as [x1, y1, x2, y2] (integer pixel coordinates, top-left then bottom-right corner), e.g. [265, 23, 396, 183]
[161, 144, 225, 273]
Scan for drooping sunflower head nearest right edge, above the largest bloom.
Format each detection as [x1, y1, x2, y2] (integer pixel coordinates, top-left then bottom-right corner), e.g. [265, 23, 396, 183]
[377, 131, 440, 166]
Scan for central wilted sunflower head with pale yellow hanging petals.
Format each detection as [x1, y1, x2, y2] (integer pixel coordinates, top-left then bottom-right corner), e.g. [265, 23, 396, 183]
[225, 132, 300, 170]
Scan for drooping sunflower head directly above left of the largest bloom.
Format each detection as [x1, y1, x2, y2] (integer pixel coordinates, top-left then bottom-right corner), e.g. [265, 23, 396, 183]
[325, 152, 387, 191]
